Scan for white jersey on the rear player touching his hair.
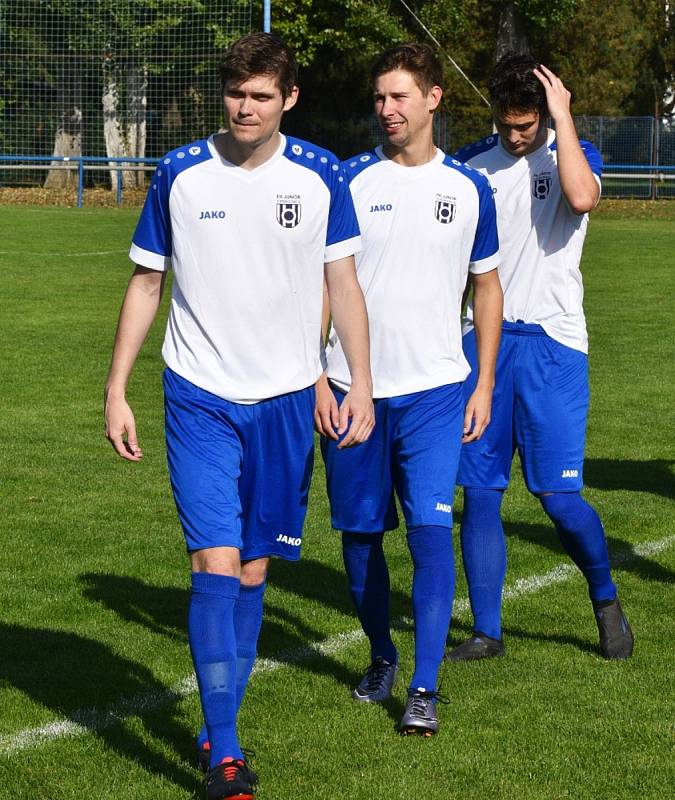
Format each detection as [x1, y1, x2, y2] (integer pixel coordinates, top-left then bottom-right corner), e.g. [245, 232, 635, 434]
[456, 130, 602, 353]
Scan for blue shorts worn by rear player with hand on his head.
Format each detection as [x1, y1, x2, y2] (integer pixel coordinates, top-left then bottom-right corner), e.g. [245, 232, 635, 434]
[457, 322, 589, 494]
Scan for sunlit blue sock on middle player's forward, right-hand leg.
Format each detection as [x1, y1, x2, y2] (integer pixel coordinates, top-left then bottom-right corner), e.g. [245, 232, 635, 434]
[408, 525, 455, 691]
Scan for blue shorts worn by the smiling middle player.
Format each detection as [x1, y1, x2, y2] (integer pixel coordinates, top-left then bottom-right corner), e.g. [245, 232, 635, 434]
[321, 383, 464, 533]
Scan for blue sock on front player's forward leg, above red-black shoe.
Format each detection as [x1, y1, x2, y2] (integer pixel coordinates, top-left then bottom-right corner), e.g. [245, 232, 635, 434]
[188, 572, 243, 767]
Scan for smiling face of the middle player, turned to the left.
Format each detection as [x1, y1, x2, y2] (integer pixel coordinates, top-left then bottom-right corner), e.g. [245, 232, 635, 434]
[373, 69, 442, 149]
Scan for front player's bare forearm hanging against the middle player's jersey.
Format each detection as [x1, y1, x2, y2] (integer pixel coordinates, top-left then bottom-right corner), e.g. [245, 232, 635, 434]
[326, 259, 372, 392]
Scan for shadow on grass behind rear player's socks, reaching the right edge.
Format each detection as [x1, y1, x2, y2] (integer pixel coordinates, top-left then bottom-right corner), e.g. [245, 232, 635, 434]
[504, 522, 675, 583]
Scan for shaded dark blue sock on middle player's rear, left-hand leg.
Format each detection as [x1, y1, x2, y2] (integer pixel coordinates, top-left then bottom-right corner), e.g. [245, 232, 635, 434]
[342, 531, 397, 664]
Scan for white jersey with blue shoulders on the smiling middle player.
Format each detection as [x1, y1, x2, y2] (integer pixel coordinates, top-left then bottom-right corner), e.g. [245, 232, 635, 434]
[327, 147, 499, 397]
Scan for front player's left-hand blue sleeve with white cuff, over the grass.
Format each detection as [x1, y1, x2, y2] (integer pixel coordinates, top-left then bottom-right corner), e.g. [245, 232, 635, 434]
[129, 160, 172, 272]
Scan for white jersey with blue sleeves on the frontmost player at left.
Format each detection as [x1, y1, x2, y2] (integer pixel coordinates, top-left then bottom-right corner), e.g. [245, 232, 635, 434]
[130, 136, 360, 403]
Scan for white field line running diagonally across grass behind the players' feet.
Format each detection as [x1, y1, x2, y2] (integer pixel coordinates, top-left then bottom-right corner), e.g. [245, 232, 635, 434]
[0, 536, 675, 756]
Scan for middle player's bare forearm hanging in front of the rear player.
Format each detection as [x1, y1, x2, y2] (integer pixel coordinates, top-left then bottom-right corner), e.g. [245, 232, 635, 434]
[473, 269, 504, 391]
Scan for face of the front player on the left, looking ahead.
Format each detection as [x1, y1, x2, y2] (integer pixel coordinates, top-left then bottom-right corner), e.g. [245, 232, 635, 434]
[223, 75, 298, 150]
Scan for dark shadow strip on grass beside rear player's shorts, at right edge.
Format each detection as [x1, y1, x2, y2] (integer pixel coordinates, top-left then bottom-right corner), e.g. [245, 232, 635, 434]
[584, 458, 675, 499]
